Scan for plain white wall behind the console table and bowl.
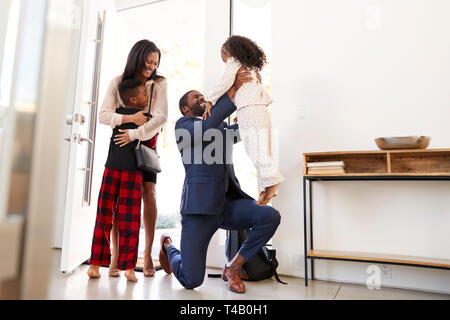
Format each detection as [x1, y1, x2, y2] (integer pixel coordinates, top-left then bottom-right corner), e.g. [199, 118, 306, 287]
[272, 0, 450, 293]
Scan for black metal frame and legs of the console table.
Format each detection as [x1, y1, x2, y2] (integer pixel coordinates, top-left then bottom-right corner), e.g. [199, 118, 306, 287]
[303, 175, 450, 286]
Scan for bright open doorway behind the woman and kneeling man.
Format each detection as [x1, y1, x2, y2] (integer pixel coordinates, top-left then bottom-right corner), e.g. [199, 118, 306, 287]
[118, 0, 206, 264]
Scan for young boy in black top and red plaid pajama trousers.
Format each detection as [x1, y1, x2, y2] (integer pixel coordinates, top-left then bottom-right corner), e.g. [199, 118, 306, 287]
[87, 79, 148, 282]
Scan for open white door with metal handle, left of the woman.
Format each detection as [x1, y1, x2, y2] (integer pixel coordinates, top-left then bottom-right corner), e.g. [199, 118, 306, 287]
[61, 0, 105, 272]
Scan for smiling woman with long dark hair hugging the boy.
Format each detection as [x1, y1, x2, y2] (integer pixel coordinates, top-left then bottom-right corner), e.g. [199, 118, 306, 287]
[98, 40, 168, 277]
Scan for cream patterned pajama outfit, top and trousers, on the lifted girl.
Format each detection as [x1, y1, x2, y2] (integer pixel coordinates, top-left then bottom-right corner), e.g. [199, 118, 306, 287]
[205, 58, 285, 193]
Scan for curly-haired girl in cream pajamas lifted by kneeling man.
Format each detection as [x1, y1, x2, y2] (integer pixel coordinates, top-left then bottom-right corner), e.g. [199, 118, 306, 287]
[203, 36, 285, 206]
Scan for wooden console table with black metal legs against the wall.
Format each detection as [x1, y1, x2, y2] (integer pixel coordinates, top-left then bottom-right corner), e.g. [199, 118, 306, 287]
[303, 149, 450, 286]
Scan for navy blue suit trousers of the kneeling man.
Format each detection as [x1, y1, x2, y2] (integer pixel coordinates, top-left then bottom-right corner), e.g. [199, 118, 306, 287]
[167, 197, 280, 289]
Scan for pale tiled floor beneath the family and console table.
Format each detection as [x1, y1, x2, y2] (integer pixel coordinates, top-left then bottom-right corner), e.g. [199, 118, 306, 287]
[48, 250, 450, 300]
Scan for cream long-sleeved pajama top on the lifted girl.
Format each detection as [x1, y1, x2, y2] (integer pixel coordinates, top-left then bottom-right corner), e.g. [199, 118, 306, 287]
[205, 57, 272, 109]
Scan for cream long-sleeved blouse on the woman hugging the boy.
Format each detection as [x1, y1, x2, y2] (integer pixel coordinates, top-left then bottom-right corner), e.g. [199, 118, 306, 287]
[99, 76, 168, 141]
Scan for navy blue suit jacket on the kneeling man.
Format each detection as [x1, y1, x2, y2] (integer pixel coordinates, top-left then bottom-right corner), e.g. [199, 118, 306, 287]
[175, 94, 253, 215]
